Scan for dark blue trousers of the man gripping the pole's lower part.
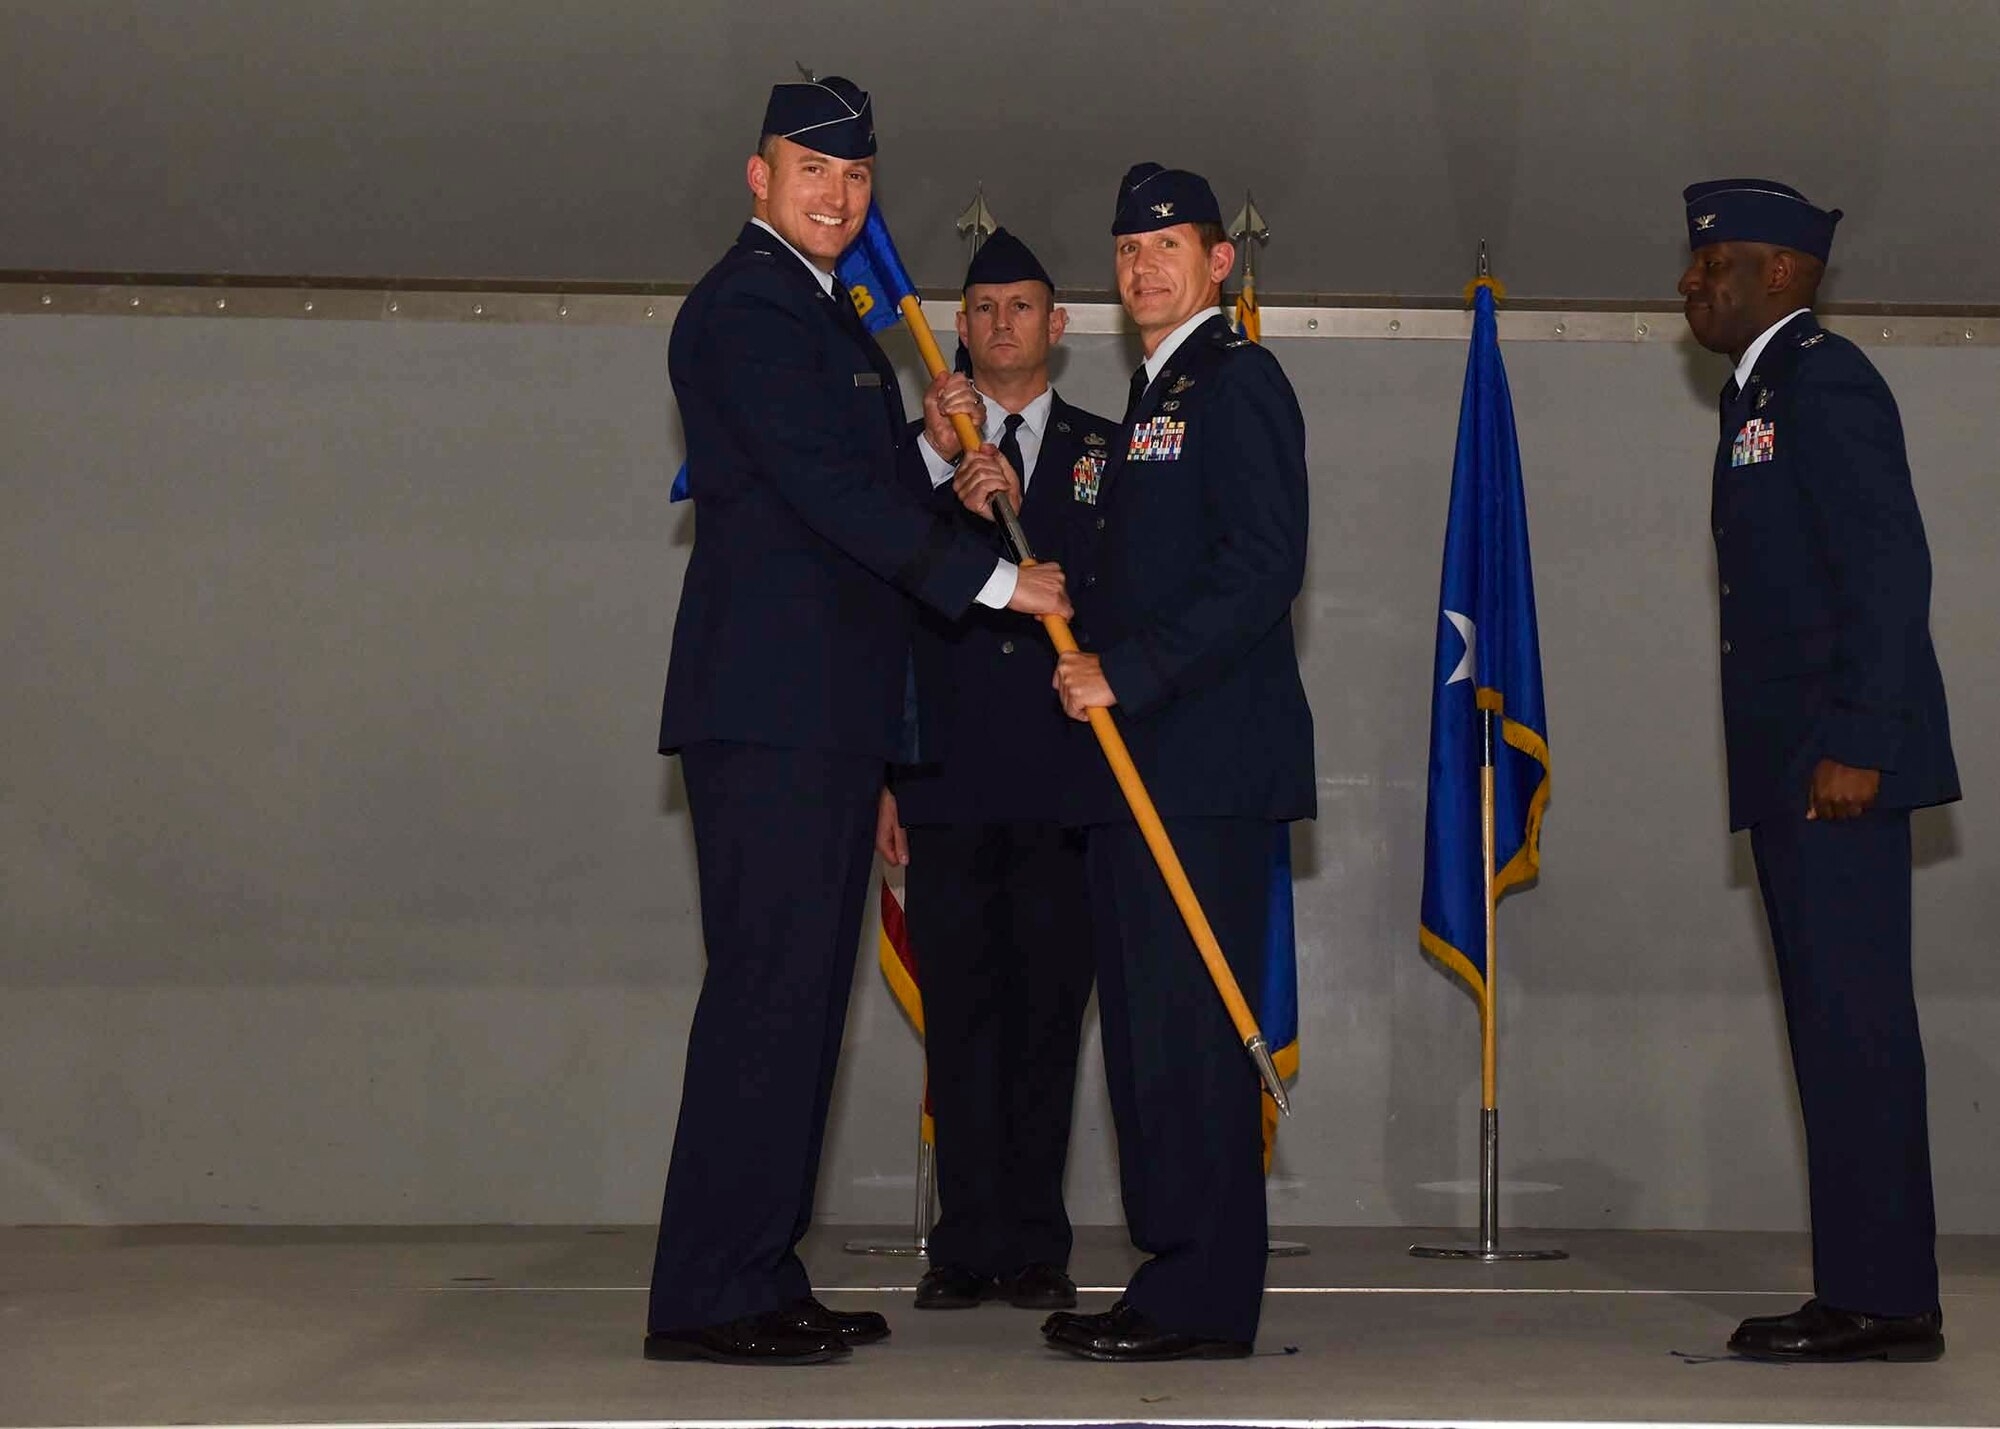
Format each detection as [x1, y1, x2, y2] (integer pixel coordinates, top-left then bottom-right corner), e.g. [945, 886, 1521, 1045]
[1086, 819, 1272, 1341]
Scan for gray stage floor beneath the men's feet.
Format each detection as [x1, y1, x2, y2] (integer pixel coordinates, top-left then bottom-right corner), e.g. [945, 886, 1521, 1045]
[0, 1227, 2000, 1427]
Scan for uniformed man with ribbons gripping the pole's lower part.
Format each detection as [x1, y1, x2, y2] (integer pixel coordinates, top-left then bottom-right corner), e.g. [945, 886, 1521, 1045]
[976, 164, 1314, 1361]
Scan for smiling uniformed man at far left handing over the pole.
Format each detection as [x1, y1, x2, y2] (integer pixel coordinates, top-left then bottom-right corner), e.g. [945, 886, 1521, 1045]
[646, 78, 1068, 1363]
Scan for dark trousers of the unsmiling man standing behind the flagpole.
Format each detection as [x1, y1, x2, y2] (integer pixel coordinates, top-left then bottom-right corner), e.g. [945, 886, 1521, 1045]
[906, 823, 1092, 1275]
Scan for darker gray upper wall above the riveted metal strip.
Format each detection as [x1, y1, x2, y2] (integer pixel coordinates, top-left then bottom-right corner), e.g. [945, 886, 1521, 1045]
[0, 0, 2000, 302]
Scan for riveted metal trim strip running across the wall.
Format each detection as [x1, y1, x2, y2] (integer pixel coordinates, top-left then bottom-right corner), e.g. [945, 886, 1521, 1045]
[0, 282, 2000, 346]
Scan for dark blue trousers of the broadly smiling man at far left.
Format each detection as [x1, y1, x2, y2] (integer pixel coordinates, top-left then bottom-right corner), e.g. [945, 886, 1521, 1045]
[646, 743, 882, 1331]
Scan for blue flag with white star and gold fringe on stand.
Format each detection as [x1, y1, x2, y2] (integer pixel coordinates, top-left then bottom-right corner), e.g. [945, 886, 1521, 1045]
[1418, 284, 1550, 1003]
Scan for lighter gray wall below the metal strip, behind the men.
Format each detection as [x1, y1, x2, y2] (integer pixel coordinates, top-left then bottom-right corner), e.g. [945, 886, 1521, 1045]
[0, 316, 2000, 1231]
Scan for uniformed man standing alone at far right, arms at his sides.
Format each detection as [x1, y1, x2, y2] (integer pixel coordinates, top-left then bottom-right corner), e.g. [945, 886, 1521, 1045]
[1680, 178, 1958, 1361]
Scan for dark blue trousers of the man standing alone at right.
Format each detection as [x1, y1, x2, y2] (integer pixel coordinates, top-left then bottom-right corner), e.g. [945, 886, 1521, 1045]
[1750, 809, 1938, 1315]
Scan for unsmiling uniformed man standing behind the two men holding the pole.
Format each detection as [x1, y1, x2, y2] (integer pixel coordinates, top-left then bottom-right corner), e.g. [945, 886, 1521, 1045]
[876, 228, 1118, 1311]
